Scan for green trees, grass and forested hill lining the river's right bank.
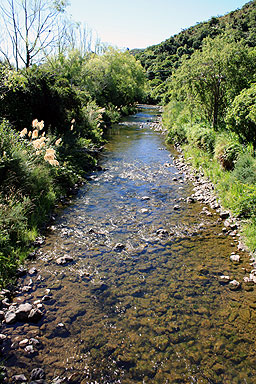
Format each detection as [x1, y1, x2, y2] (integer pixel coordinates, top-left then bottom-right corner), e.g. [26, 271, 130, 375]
[134, 1, 256, 251]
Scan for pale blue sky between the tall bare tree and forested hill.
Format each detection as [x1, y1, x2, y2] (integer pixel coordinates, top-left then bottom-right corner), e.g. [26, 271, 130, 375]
[67, 0, 248, 49]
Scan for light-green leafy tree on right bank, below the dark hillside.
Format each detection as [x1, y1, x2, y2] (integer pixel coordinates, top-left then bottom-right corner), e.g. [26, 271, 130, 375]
[171, 36, 256, 128]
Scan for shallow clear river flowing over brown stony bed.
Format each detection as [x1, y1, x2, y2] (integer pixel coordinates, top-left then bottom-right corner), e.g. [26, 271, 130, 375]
[4, 106, 256, 384]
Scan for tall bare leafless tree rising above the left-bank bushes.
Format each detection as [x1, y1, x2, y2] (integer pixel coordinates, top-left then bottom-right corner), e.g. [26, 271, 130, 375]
[0, 0, 68, 69]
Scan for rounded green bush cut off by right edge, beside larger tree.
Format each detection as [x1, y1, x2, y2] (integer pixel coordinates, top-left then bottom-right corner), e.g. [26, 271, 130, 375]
[226, 83, 256, 148]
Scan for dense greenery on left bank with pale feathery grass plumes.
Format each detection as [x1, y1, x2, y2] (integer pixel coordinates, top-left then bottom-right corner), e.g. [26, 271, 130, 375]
[0, 48, 145, 285]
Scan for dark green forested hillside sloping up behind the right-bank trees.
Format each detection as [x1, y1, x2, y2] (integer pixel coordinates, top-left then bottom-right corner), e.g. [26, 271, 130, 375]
[134, 0, 256, 98]
